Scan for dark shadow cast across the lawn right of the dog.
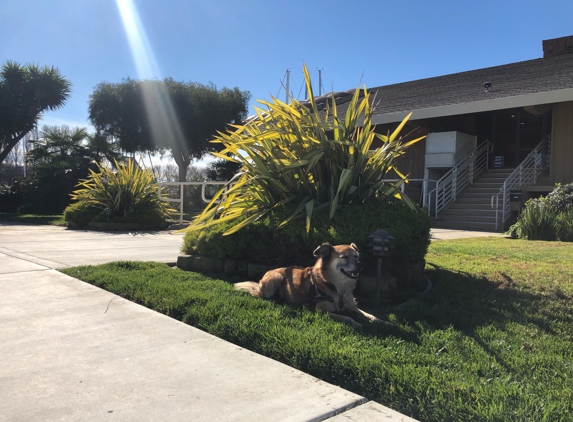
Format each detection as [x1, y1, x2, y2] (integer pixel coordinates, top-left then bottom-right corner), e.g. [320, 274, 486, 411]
[200, 263, 573, 350]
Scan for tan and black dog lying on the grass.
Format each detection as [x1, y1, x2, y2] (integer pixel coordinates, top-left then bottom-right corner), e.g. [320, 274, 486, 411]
[235, 243, 392, 328]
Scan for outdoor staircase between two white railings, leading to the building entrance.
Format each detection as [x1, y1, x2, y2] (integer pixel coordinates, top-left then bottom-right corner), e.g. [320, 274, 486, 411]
[433, 169, 514, 231]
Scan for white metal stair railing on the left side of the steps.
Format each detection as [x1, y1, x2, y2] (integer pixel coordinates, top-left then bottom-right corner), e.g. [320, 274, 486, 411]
[423, 141, 490, 217]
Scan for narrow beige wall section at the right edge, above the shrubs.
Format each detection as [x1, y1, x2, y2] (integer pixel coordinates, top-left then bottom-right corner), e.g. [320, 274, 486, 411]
[550, 101, 573, 184]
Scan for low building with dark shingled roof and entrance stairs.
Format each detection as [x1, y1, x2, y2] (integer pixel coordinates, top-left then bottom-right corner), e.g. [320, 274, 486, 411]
[325, 36, 573, 230]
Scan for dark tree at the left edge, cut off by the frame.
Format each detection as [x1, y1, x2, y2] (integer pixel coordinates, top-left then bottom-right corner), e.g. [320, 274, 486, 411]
[0, 61, 71, 163]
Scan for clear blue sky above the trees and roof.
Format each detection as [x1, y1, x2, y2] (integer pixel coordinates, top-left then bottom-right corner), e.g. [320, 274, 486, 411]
[0, 0, 573, 132]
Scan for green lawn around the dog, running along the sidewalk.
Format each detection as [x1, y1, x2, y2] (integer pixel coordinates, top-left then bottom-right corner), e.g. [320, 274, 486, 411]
[64, 238, 573, 421]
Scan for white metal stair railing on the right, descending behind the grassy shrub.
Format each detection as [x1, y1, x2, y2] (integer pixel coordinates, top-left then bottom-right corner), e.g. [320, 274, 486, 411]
[491, 135, 551, 230]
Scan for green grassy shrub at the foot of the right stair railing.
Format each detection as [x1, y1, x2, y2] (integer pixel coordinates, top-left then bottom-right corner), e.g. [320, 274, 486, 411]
[509, 199, 559, 240]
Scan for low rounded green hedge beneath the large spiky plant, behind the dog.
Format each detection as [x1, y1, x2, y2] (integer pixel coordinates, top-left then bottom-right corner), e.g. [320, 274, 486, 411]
[182, 200, 430, 276]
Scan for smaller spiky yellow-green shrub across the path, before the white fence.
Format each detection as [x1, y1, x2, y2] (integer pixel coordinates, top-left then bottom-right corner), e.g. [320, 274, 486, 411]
[66, 161, 174, 223]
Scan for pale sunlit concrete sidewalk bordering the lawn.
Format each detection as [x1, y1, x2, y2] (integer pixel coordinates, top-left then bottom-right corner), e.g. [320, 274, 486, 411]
[0, 222, 412, 421]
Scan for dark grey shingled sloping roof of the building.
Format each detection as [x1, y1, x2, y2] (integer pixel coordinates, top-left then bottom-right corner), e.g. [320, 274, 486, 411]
[321, 50, 573, 124]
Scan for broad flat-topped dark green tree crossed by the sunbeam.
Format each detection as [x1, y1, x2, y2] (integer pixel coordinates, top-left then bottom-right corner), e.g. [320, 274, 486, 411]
[89, 78, 250, 182]
